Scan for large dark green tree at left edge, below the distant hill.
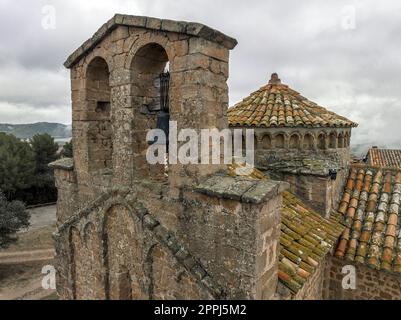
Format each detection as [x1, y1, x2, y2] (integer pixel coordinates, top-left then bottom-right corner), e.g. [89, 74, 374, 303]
[0, 133, 35, 199]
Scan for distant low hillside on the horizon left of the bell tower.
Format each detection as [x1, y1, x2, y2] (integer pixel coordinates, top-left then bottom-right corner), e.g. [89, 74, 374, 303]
[0, 122, 71, 139]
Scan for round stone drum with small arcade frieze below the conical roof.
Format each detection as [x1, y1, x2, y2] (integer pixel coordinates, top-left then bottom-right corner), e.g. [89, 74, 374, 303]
[247, 128, 351, 216]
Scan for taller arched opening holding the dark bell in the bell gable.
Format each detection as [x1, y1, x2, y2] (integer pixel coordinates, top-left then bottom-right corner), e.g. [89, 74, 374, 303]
[131, 43, 170, 181]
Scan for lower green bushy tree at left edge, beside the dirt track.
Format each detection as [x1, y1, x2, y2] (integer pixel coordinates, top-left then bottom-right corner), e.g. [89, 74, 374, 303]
[0, 192, 30, 248]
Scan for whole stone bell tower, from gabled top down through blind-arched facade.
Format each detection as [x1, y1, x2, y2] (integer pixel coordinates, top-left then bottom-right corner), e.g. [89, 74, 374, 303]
[52, 15, 285, 299]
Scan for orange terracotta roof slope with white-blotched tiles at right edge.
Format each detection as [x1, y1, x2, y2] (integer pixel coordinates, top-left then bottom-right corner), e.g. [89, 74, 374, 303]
[335, 165, 401, 273]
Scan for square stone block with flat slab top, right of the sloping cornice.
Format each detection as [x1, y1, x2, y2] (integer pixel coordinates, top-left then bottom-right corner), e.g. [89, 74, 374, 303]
[186, 176, 283, 299]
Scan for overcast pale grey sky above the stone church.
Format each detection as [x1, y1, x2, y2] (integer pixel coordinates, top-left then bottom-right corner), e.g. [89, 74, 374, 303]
[0, 0, 401, 148]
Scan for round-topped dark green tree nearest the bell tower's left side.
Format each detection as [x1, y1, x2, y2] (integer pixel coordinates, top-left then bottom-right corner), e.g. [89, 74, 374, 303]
[31, 133, 59, 174]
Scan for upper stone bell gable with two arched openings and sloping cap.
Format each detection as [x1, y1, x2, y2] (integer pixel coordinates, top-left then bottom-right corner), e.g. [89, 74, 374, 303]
[60, 14, 237, 209]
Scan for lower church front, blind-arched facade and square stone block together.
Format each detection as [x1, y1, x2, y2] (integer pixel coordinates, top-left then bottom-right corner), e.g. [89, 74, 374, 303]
[55, 177, 282, 299]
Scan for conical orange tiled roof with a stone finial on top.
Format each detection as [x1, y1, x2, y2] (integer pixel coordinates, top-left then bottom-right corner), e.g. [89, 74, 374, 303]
[228, 73, 357, 127]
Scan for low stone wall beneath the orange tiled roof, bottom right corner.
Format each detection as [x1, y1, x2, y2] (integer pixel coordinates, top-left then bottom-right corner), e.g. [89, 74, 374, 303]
[325, 256, 401, 300]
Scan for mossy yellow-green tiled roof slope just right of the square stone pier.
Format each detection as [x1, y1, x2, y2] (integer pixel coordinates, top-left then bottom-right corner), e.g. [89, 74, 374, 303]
[228, 164, 342, 294]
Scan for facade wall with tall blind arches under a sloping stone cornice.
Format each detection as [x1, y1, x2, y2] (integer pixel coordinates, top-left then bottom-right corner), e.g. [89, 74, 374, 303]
[55, 188, 213, 299]
